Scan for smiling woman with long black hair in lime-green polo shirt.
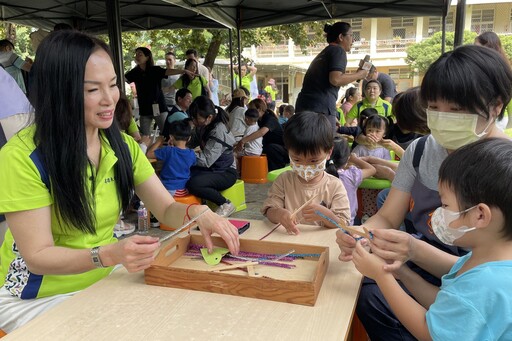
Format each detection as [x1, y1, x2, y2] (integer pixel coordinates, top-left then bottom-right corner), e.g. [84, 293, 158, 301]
[0, 31, 239, 332]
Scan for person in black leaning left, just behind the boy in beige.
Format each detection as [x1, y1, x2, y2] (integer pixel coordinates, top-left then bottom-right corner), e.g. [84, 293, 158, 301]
[235, 98, 290, 171]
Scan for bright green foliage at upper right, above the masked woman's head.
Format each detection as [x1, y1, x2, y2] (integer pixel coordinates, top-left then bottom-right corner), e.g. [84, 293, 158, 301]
[406, 31, 477, 74]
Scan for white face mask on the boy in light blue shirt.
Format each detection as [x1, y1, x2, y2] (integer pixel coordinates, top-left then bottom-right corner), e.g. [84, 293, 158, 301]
[431, 206, 476, 245]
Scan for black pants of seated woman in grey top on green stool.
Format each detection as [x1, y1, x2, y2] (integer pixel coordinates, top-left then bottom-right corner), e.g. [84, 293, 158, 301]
[187, 168, 238, 206]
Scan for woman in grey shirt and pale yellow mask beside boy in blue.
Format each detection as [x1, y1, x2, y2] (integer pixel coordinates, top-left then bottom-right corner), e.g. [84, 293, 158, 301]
[337, 46, 512, 341]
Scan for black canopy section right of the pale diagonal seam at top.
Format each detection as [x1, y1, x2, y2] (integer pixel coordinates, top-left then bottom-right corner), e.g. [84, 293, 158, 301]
[165, 0, 450, 29]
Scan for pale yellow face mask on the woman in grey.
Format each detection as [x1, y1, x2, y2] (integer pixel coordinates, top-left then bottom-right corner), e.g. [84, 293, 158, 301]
[427, 109, 494, 150]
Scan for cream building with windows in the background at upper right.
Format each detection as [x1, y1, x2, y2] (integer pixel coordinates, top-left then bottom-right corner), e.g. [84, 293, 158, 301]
[216, 0, 512, 105]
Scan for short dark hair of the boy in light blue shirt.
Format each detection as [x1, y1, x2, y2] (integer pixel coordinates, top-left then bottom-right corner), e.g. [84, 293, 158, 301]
[439, 138, 512, 240]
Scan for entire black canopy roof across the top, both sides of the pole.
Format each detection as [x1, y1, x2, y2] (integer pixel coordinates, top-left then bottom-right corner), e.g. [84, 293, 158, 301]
[0, 0, 449, 33]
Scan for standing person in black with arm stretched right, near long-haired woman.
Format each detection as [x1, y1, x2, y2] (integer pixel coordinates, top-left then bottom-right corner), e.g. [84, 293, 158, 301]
[124, 47, 189, 135]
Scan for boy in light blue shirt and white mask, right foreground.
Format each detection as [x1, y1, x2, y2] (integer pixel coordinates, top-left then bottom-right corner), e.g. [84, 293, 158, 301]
[353, 138, 512, 340]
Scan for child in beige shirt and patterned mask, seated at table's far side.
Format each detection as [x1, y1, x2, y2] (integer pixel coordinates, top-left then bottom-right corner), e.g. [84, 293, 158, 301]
[261, 111, 350, 234]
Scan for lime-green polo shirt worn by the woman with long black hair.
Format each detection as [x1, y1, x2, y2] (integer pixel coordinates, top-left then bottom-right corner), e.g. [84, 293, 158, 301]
[0, 126, 154, 299]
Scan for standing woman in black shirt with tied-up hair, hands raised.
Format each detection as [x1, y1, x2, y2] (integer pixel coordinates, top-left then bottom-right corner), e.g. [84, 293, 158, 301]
[295, 22, 368, 132]
